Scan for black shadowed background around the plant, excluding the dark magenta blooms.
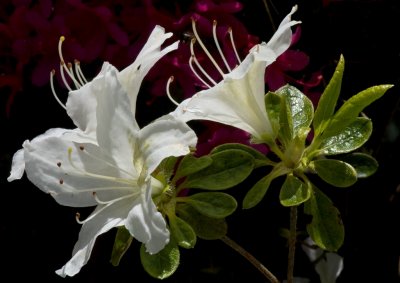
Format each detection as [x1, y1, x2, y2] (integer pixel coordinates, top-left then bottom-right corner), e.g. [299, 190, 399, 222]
[0, 0, 400, 283]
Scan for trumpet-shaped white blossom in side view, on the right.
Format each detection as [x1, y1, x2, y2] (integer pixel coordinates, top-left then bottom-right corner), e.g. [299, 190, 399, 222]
[173, 6, 299, 143]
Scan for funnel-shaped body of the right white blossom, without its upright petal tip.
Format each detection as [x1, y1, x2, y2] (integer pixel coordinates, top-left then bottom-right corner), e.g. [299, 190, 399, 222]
[172, 56, 273, 143]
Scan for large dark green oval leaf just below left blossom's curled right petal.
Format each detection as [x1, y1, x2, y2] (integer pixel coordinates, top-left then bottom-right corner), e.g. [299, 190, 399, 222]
[181, 149, 254, 190]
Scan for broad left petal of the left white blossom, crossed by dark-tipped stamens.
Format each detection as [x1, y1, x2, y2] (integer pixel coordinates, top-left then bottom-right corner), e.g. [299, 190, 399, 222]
[24, 137, 135, 207]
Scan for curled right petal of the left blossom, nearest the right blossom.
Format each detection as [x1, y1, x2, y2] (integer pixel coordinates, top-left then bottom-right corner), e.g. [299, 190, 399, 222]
[135, 116, 197, 173]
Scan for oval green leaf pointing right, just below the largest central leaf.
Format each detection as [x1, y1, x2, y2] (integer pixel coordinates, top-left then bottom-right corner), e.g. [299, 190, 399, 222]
[185, 192, 237, 218]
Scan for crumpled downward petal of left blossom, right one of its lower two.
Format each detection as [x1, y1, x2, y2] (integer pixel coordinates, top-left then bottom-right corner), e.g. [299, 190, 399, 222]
[125, 181, 169, 254]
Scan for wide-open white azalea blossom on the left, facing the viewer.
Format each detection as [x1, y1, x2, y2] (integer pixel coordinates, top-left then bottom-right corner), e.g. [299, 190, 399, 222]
[8, 26, 197, 277]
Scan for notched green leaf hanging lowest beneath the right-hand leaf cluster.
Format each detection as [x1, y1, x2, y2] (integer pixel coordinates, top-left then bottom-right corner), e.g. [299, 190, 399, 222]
[304, 187, 344, 252]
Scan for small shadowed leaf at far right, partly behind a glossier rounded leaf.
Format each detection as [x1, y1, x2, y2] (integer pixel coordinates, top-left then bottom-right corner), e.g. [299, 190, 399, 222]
[339, 152, 379, 178]
